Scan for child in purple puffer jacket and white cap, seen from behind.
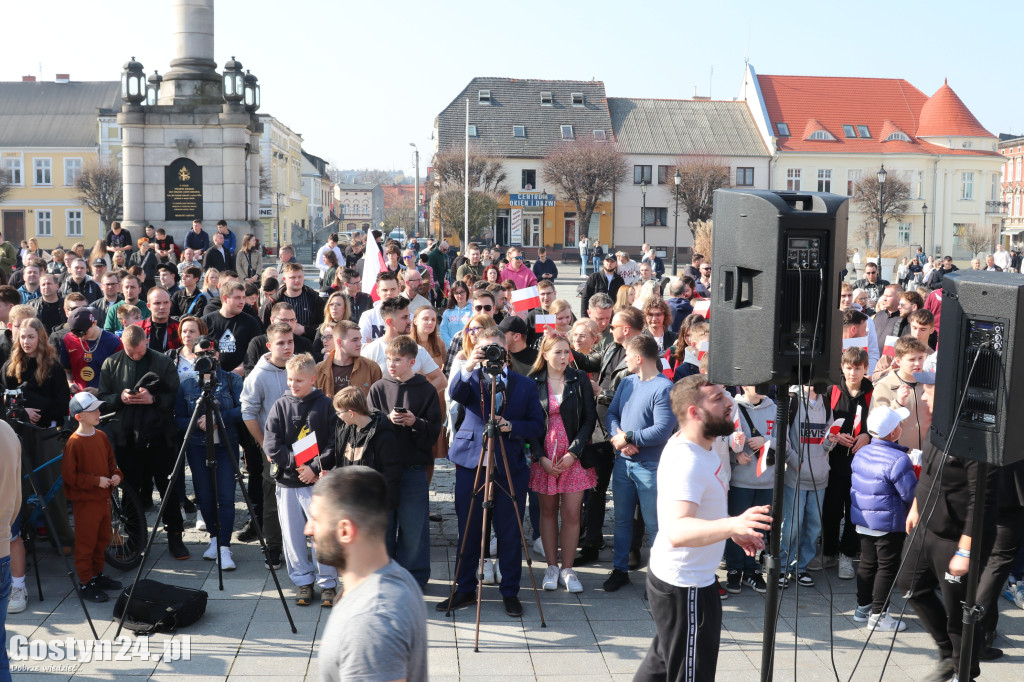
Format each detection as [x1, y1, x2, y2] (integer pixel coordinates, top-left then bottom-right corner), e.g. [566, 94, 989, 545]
[850, 407, 918, 632]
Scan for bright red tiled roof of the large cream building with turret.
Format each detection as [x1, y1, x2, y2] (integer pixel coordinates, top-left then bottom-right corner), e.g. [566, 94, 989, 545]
[758, 75, 994, 156]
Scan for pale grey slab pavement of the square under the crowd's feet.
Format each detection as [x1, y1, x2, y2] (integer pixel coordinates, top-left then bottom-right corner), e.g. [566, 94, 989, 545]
[7, 270, 1024, 682]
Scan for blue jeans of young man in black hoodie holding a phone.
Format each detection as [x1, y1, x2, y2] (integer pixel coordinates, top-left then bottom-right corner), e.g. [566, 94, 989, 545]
[386, 464, 430, 587]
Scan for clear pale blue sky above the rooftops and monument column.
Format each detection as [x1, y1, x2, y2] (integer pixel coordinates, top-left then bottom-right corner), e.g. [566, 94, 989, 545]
[0, 0, 1024, 173]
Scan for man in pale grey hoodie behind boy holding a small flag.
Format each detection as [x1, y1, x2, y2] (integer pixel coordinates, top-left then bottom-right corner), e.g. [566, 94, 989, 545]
[242, 323, 295, 568]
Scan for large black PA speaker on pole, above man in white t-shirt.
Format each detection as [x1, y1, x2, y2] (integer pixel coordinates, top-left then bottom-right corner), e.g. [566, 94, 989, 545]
[708, 189, 847, 385]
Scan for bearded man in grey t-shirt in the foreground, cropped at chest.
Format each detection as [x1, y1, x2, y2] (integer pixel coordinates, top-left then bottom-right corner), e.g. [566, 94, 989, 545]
[305, 466, 429, 682]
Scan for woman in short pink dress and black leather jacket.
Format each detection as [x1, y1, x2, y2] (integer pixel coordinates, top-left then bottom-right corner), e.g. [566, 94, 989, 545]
[529, 336, 597, 592]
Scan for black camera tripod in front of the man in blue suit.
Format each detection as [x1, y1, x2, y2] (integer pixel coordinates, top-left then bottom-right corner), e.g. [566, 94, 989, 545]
[444, 363, 548, 652]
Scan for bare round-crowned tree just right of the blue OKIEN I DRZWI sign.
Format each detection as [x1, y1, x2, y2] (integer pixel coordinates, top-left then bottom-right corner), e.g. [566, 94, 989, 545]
[542, 139, 629, 240]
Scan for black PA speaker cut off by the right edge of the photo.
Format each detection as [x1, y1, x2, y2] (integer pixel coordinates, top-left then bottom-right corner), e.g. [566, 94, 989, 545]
[929, 270, 1024, 466]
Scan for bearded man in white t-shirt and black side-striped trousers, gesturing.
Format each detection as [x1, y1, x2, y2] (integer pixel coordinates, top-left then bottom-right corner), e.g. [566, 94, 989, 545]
[633, 375, 771, 682]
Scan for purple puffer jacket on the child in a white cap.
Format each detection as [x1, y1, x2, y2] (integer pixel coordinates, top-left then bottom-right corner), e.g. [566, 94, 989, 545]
[850, 438, 918, 532]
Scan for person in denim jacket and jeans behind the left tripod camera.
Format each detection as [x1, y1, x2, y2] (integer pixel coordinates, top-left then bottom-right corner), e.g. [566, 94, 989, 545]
[174, 337, 242, 570]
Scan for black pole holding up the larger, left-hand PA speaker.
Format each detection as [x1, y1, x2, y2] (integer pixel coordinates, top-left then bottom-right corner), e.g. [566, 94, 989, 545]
[761, 383, 786, 682]
